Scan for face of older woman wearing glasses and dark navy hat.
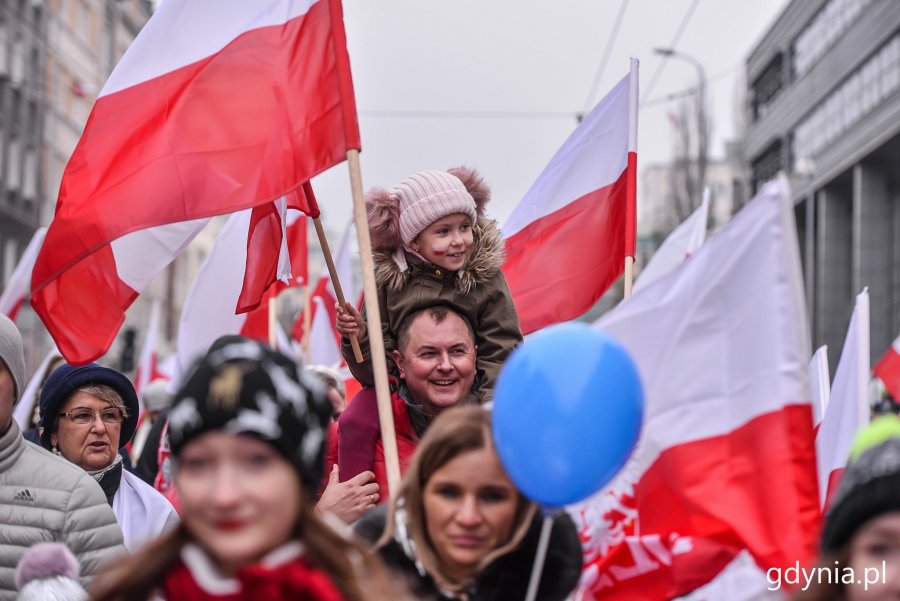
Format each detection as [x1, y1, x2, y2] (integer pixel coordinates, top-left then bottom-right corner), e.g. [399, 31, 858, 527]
[50, 390, 123, 471]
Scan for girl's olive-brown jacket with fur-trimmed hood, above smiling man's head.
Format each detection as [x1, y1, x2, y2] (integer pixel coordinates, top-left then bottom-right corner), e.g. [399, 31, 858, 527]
[341, 218, 522, 402]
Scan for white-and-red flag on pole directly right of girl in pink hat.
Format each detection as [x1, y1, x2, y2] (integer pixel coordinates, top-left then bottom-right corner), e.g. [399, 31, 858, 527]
[503, 61, 638, 333]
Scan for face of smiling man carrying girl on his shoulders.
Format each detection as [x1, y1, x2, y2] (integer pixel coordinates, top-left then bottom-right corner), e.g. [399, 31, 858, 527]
[393, 312, 476, 416]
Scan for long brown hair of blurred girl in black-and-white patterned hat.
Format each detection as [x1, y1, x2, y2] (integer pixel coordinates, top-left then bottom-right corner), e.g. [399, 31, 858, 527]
[91, 468, 405, 601]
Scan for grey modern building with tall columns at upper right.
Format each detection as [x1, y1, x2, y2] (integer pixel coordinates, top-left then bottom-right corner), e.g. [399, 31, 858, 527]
[745, 0, 900, 372]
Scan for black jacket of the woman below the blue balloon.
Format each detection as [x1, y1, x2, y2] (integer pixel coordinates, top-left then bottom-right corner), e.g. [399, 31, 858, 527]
[354, 505, 582, 601]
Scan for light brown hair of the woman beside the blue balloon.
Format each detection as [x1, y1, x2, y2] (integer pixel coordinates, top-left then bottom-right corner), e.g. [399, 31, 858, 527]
[376, 405, 537, 591]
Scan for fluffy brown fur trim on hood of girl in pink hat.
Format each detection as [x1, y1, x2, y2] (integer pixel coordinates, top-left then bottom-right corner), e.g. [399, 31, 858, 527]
[373, 217, 506, 294]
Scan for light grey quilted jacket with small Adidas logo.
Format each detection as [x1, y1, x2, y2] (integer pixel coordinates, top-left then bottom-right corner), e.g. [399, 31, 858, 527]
[0, 420, 125, 600]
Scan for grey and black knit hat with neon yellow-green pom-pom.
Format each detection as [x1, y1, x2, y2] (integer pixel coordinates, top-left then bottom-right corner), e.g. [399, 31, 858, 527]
[822, 415, 900, 553]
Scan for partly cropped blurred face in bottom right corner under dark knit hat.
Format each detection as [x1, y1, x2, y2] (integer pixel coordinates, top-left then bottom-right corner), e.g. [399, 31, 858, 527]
[845, 511, 900, 601]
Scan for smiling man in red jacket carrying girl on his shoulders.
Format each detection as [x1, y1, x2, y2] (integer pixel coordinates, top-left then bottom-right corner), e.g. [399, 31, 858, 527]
[329, 305, 478, 501]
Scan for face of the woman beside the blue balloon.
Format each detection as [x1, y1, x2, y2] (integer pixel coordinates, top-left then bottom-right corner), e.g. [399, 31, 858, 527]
[422, 448, 519, 580]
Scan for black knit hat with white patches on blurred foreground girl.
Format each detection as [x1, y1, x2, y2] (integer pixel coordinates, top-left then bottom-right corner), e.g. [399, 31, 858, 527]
[169, 336, 332, 489]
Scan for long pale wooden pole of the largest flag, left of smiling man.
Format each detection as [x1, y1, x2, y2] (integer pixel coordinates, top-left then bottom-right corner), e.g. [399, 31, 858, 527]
[347, 150, 400, 495]
